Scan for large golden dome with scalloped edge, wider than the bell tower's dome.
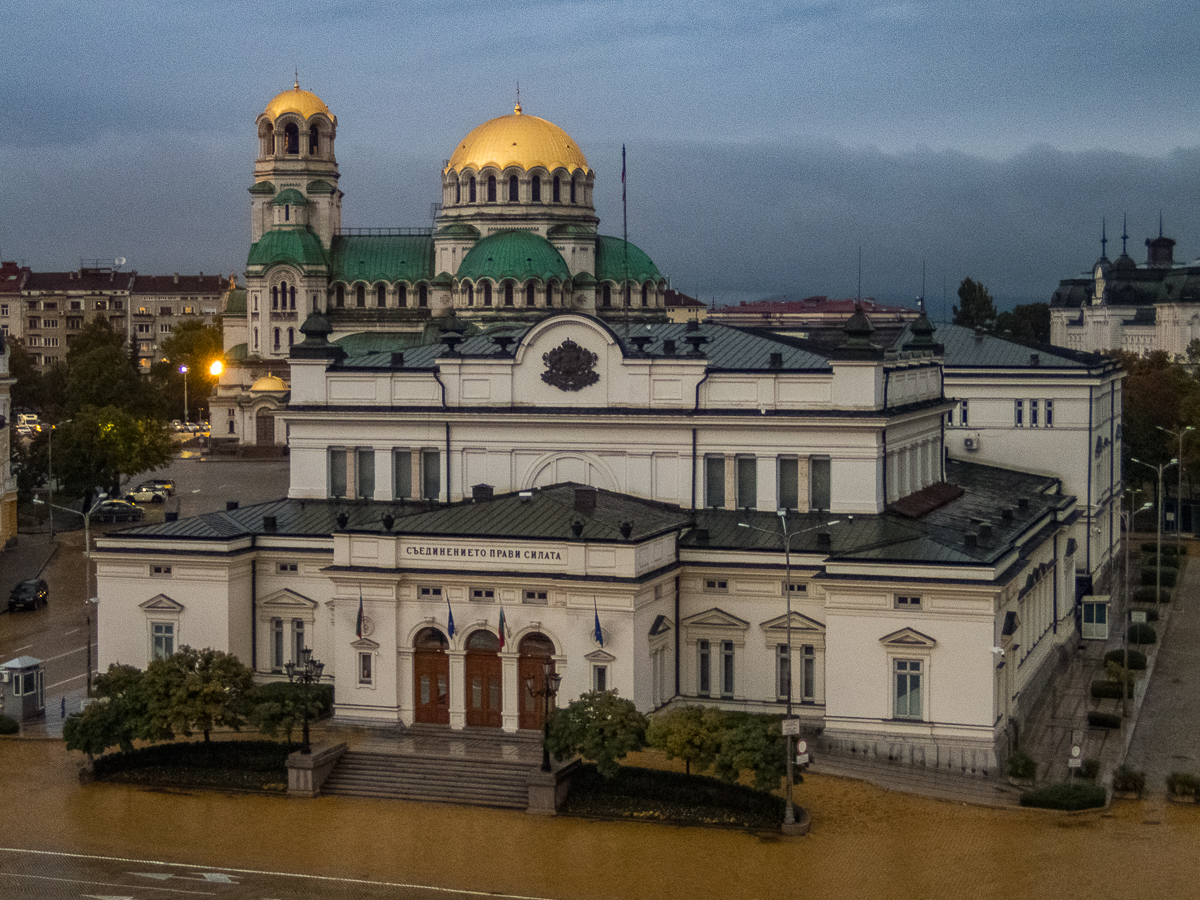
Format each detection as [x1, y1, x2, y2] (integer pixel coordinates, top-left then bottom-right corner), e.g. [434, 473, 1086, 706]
[445, 103, 590, 172]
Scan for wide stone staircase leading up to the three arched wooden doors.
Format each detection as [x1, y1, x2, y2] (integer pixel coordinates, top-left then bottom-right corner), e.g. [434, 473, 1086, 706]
[322, 750, 538, 809]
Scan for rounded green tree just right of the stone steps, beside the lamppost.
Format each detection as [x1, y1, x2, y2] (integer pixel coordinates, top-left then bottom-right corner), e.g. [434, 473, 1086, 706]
[548, 690, 646, 778]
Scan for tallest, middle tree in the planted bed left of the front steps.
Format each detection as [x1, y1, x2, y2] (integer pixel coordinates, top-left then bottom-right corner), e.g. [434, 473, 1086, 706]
[142, 647, 254, 743]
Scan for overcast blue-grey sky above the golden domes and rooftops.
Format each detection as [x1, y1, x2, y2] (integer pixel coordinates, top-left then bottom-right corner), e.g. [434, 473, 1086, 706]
[0, 0, 1200, 317]
